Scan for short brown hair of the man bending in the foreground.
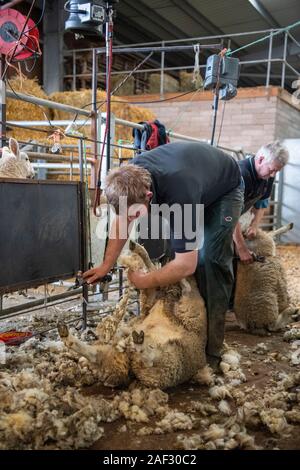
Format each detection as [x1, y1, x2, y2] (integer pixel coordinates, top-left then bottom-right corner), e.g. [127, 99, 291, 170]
[105, 164, 151, 214]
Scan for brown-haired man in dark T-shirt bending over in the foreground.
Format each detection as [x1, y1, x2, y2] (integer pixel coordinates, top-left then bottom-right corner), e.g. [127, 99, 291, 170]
[83, 142, 244, 368]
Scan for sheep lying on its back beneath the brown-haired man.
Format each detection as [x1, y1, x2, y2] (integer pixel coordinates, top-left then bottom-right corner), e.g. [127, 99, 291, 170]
[58, 242, 207, 389]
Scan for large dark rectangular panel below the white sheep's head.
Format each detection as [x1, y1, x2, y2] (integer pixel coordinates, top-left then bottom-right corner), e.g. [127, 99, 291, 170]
[0, 179, 82, 294]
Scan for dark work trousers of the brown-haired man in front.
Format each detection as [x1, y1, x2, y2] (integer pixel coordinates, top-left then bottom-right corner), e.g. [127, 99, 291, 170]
[195, 183, 244, 360]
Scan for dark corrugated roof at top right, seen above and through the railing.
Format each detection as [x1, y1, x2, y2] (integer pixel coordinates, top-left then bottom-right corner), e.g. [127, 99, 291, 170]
[115, 0, 300, 89]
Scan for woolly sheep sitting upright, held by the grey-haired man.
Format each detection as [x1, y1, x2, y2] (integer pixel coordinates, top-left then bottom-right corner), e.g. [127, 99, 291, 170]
[233, 220, 298, 334]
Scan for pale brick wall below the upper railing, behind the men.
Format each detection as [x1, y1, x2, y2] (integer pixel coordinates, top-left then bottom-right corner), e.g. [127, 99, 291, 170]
[126, 87, 300, 152]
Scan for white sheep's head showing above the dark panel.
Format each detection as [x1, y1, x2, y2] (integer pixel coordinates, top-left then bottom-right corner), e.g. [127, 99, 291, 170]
[0, 138, 34, 179]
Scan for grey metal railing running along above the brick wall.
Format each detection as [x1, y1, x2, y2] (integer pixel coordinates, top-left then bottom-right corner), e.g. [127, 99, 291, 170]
[64, 29, 300, 96]
